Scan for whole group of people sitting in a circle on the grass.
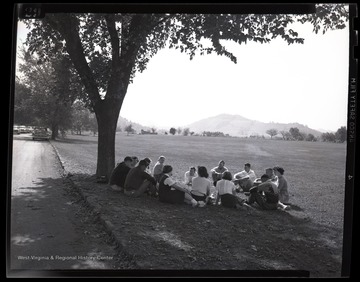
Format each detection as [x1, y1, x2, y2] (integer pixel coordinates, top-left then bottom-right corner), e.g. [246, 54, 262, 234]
[109, 156, 290, 210]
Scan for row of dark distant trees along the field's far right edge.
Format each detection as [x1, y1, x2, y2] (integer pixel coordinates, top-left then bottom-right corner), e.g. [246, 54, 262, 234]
[266, 126, 347, 143]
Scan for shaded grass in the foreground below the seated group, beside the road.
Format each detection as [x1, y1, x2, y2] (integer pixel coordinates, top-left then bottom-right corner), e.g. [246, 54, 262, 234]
[66, 174, 342, 277]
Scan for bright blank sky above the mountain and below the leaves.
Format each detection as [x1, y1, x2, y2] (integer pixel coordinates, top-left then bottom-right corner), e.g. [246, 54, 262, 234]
[15, 18, 349, 131]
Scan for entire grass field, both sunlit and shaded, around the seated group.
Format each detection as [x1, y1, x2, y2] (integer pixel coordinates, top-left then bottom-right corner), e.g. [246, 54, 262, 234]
[51, 133, 346, 277]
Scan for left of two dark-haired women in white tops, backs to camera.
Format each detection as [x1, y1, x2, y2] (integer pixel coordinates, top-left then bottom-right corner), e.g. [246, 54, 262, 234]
[191, 166, 212, 203]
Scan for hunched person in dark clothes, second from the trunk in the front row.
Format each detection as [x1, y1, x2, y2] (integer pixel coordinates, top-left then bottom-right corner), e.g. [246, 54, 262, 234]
[124, 160, 156, 197]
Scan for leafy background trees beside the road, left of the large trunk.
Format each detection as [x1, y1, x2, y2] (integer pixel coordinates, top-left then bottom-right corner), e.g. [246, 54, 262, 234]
[14, 49, 97, 139]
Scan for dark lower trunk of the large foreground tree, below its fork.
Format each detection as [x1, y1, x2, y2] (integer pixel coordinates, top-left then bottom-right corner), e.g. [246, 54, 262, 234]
[95, 96, 123, 179]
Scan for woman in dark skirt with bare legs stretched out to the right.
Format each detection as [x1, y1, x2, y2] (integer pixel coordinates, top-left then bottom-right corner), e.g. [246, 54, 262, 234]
[159, 165, 205, 207]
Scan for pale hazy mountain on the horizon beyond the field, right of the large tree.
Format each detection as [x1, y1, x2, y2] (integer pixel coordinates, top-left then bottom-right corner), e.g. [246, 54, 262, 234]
[184, 114, 321, 137]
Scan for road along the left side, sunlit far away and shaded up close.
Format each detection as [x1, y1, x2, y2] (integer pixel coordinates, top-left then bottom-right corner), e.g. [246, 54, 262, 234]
[8, 135, 130, 272]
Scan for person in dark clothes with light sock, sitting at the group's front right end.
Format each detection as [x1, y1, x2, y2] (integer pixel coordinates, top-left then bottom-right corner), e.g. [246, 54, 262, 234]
[247, 174, 288, 210]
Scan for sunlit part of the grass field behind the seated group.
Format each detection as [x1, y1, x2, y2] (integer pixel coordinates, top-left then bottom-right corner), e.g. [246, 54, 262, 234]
[54, 133, 346, 228]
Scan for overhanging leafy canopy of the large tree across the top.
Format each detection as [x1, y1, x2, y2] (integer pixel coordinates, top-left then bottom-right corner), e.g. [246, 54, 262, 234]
[26, 4, 348, 106]
